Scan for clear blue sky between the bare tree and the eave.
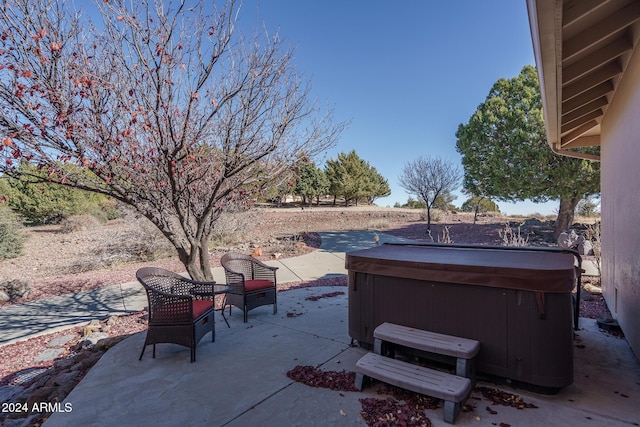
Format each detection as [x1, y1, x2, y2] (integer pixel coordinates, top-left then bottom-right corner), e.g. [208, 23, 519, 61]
[239, 0, 557, 214]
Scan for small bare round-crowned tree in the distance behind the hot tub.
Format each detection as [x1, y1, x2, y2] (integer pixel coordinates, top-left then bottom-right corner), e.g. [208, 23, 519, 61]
[398, 156, 461, 233]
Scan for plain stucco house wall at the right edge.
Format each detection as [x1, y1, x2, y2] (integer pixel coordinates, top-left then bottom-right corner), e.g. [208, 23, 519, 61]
[601, 44, 640, 359]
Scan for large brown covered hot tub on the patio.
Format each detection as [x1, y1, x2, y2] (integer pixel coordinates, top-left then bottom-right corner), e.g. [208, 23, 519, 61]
[345, 244, 579, 390]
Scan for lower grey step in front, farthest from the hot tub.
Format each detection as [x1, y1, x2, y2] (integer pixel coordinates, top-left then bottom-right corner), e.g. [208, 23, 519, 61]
[355, 353, 472, 424]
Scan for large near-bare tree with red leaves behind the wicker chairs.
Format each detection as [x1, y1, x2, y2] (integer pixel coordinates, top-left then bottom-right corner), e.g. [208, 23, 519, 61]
[0, 0, 344, 280]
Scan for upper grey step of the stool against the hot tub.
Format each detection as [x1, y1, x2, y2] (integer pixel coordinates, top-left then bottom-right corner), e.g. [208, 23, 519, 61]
[373, 322, 480, 383]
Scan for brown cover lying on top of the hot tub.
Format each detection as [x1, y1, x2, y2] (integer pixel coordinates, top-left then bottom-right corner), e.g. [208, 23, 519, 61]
[345, 244, 577, 293]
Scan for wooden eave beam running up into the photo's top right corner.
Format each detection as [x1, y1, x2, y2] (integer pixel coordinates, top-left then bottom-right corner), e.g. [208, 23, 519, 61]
[562, 1, 640, 62]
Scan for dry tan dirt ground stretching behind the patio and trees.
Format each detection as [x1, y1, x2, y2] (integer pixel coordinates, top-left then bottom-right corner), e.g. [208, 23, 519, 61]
[0, 206, 596, 302]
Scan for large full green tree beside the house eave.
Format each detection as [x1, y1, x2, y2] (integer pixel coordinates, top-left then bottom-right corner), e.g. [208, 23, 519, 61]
[456, 65, 600, 236]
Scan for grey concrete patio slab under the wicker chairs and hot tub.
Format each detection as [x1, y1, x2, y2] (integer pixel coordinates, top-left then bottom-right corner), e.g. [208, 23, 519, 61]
[45, 287, 640, 427]
